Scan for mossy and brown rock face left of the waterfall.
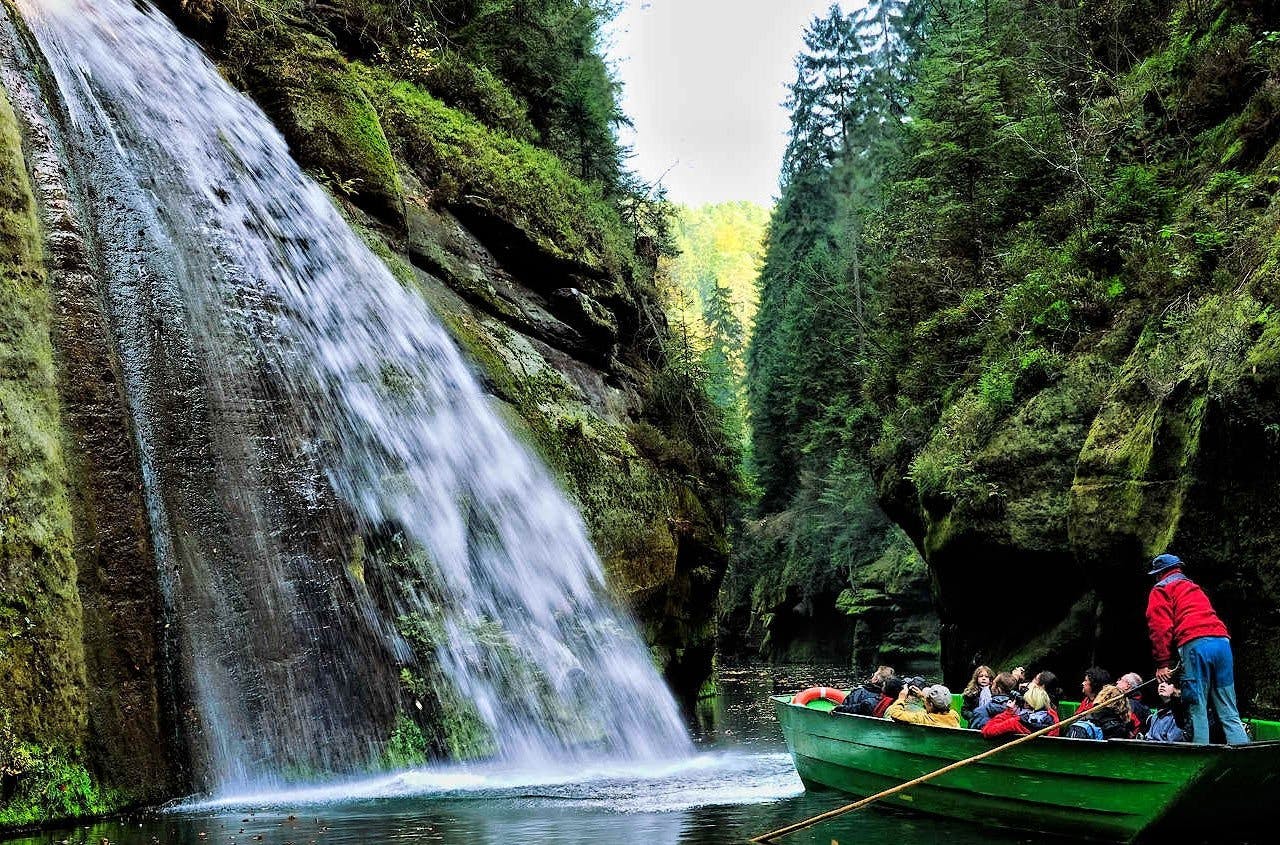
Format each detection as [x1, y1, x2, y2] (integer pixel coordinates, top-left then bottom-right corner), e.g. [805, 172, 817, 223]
[0, 20, 182, 825]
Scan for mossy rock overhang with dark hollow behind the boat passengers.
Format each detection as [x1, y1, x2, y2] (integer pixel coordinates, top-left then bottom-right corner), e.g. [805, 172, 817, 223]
[882, 291, 1280, 713]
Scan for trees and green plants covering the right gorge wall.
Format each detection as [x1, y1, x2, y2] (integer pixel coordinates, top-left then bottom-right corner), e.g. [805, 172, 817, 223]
[748, 0, 1280, 658]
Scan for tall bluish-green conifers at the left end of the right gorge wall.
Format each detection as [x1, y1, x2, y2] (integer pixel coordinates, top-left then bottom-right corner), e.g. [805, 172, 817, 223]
[722, 0, 929, 659]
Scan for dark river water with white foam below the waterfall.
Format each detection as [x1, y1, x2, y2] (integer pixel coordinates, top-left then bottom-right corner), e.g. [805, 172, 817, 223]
[6, 666, 1048, 845]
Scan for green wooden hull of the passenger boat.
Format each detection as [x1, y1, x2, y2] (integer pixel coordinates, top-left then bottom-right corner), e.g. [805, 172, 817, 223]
[773, 695, 1280, 841]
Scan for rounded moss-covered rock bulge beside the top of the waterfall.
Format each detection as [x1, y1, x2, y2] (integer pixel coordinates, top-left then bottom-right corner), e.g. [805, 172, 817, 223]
[229, 26, 404, 223]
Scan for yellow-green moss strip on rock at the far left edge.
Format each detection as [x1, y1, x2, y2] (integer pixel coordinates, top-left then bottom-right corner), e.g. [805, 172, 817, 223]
[0, 87, 86, 783]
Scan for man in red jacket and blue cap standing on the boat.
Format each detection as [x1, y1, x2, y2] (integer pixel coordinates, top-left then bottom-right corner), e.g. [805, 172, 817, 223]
[1147, 554, 1249, 745]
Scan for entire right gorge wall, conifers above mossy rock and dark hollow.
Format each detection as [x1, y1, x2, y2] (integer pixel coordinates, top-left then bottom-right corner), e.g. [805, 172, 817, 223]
[747, 0, 1280, 701]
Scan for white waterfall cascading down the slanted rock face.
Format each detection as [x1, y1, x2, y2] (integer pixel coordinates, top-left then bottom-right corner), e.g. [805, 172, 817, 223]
[6, 0, 689, 794]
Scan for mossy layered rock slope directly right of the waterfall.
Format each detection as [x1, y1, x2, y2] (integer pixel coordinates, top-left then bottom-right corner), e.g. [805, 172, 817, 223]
[166, 9, 728, 693]
